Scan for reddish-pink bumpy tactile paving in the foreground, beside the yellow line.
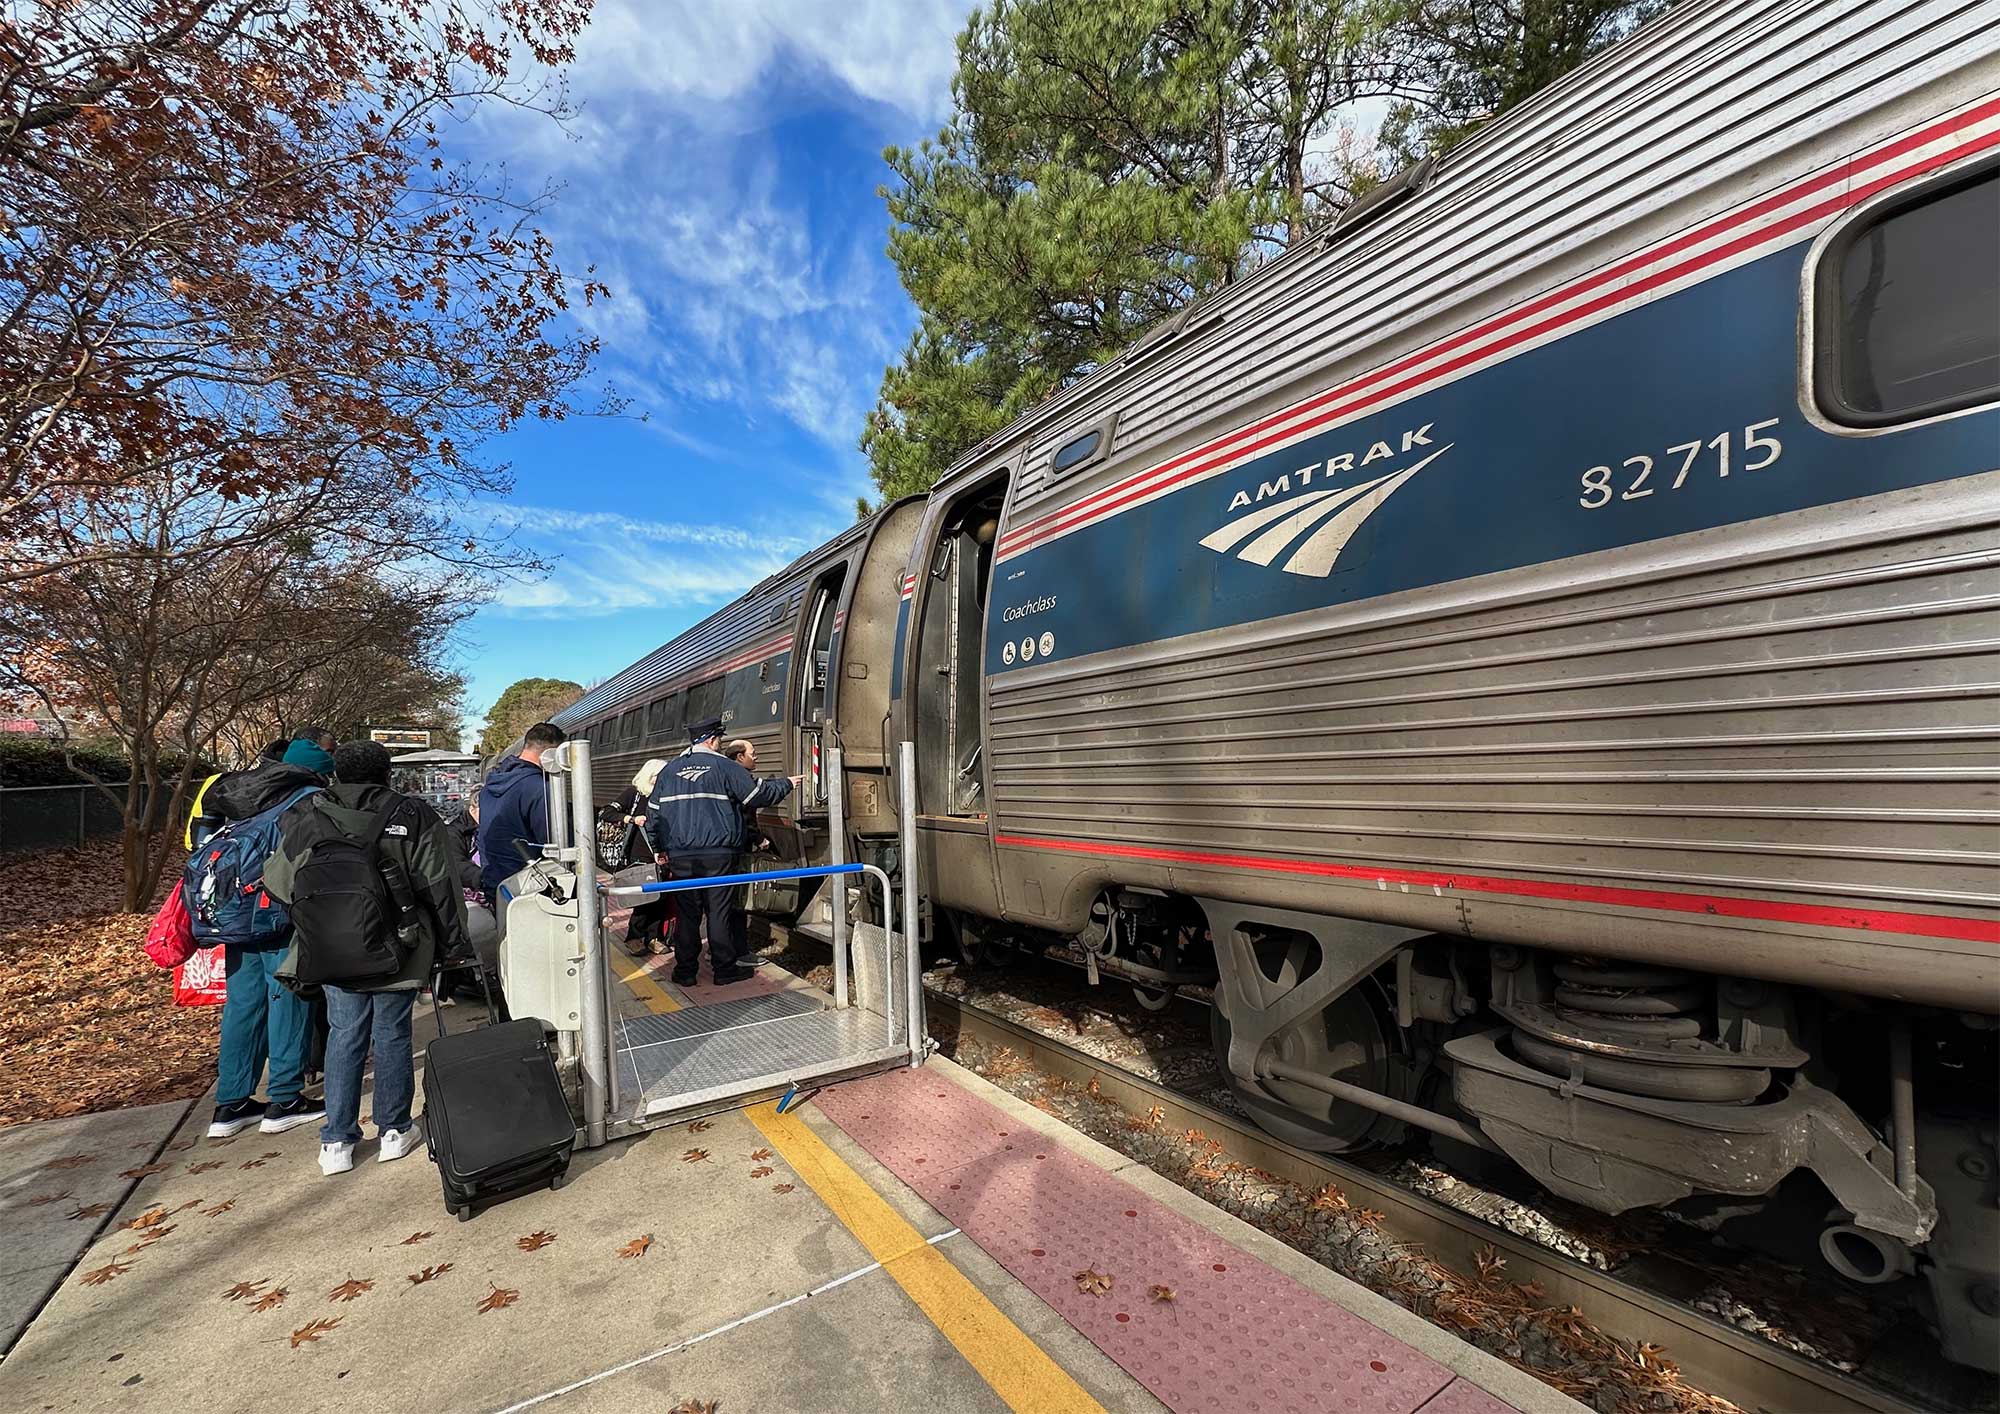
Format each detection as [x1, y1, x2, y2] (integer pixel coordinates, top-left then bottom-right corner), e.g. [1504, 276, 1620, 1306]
[818, 1070, 1472, 1414]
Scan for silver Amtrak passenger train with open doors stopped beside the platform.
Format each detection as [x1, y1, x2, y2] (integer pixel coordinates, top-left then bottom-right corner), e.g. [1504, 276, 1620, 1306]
[564, 0, 2000, 1368]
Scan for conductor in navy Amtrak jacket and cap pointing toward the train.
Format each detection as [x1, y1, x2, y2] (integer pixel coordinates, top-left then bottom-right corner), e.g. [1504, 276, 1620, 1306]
[646, 720, 800, 986]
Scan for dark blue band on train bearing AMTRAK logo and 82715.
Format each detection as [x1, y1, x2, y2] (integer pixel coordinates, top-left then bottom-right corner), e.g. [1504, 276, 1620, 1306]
[984, 244, 2000, 682]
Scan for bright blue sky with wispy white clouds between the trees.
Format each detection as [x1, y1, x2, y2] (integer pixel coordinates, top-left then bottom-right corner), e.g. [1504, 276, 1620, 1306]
[458, 0, 972, 748]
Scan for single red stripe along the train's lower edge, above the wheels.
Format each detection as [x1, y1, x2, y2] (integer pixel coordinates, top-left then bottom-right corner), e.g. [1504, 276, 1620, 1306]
[996, 834, 2000, 944]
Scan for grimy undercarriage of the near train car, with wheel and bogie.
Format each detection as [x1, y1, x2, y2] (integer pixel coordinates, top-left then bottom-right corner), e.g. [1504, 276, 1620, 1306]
[936, 888, 2000, 1370]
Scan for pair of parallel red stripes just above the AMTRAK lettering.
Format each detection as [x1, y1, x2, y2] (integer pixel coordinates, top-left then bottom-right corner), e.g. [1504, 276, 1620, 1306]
[998, 98, 2000, 556]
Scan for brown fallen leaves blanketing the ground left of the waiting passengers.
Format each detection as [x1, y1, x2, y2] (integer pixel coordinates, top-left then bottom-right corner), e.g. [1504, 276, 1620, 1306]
[0, 838, 220, 1128]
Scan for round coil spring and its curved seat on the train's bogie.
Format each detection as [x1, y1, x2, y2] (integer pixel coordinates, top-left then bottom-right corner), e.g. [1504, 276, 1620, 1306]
[1514, 960, 1770, 1104]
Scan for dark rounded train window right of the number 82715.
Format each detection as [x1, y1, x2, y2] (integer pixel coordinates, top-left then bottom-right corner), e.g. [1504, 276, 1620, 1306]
[1814, 168, 2000, 428]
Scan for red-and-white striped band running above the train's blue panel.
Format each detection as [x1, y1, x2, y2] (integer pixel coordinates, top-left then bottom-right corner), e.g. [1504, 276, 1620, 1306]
[998, 96, 2000, 560]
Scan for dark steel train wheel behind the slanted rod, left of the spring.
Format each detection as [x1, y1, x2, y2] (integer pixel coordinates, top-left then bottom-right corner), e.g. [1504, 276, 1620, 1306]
[1208, 982, 1402, 1154]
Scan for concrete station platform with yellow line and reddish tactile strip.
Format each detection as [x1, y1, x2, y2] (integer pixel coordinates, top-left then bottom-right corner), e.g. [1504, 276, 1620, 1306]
[0, 930, 1582, 1414]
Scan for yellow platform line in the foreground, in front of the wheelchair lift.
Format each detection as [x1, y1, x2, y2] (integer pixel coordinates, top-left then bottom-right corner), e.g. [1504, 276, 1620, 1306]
[748, 1104, 1104, 1414]
